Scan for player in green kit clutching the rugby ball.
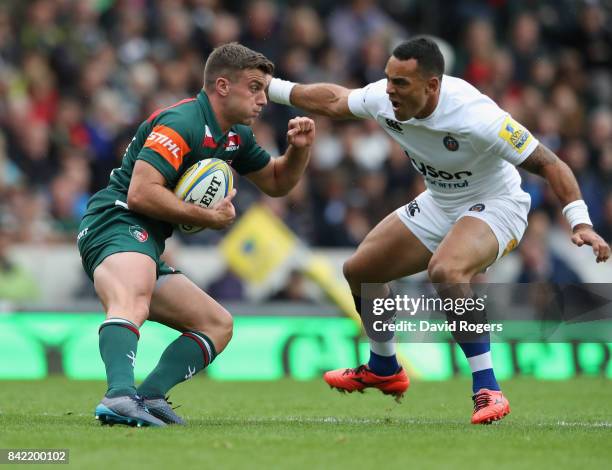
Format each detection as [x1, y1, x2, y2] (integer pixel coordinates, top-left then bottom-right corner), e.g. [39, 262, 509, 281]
[77, 43, 315, 426]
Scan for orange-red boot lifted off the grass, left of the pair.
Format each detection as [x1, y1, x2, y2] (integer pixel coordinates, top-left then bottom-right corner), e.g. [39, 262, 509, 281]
[323, 365, 410, 403]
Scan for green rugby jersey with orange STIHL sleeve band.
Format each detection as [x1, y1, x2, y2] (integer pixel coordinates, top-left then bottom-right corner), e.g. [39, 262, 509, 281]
[85, 90, 270, 238]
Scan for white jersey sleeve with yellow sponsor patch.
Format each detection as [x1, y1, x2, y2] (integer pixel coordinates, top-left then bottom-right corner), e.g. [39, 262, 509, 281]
[470, 99, 539, 166]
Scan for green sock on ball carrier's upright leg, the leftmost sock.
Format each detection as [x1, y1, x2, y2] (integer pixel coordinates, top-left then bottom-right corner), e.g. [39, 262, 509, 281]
[99, 318, 140, 398]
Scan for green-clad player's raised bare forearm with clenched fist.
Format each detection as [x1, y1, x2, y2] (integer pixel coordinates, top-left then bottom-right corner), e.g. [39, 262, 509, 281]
[247, 117, 315, 197]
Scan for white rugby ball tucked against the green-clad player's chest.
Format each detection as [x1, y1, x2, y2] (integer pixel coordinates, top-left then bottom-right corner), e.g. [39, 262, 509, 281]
[174, 158, 234, 233]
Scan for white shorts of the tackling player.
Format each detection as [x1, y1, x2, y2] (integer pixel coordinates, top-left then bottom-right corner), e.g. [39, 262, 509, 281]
[395, 191, 531, 259]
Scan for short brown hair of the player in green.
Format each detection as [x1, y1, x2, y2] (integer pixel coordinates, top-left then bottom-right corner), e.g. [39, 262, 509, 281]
[204, 42, 274, 88]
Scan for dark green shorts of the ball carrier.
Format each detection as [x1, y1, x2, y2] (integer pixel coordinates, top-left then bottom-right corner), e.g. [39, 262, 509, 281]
[77, 206, 180, 281]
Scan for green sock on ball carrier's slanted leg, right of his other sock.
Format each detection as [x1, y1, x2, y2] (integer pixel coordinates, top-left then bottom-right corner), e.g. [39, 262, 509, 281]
[137, 331, 216, 398]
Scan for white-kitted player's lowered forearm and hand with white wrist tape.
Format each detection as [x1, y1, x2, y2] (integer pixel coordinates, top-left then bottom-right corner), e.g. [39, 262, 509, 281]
[520, 144, 610, 263]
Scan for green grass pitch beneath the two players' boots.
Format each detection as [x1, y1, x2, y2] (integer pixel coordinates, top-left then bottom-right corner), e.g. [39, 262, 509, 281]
[0, 377, 612, 470]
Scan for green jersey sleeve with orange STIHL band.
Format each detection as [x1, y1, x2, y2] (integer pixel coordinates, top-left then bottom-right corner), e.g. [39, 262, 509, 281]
[136, 112, 191, 187]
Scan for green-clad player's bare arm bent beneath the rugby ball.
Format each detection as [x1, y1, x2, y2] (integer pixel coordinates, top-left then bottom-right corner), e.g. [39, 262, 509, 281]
[127, 160, 236, 230]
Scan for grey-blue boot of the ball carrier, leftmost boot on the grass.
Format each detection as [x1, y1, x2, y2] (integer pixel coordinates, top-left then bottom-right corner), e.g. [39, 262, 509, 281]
[94, 395, 166, 427]
